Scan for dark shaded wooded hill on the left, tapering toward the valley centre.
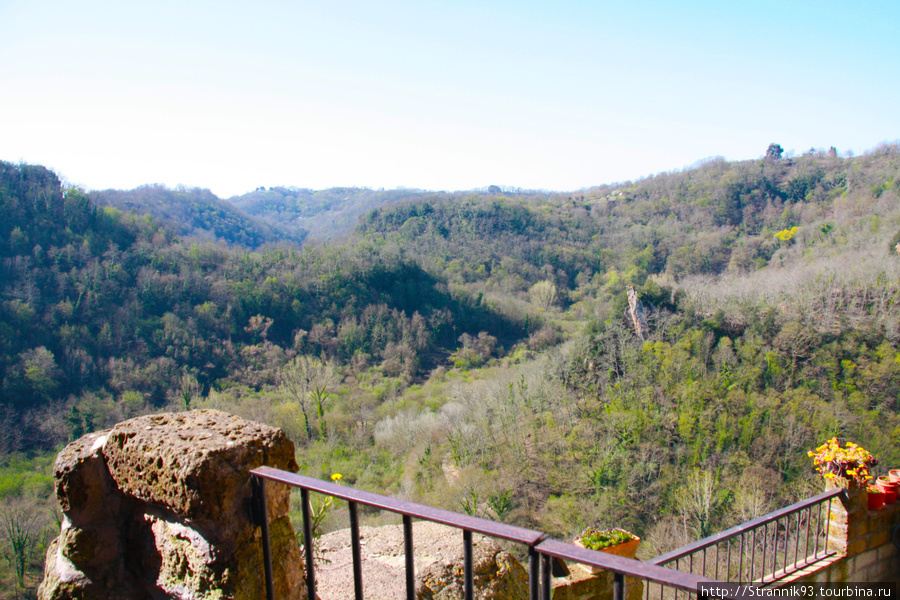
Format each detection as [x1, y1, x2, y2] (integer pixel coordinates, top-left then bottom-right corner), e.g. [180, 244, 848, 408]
[0, 163, 523, 451]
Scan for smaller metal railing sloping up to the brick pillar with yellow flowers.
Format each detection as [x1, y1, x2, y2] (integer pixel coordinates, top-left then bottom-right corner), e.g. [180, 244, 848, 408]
[647, 489, 845, 598]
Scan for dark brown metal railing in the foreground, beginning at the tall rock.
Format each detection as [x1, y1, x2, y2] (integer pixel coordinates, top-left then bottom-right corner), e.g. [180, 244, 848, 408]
[250, 467, 717, 600]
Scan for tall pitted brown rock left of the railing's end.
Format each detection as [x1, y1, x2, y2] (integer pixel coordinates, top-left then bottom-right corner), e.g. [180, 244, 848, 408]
[38, 410, 306, 600]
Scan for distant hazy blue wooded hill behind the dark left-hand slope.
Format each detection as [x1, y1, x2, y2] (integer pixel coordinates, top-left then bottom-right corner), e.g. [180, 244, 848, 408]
[90, 185, 306, 249]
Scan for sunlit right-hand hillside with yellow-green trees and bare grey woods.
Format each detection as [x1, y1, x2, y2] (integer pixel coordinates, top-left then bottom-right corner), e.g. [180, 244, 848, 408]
[344, 147, 900, 551]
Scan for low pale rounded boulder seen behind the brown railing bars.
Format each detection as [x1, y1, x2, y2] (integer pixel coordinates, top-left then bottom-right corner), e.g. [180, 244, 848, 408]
[316, 521, 528, 600]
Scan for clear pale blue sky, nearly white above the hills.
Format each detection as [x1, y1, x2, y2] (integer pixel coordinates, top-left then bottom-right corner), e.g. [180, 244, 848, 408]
[0, 0, 900, 198]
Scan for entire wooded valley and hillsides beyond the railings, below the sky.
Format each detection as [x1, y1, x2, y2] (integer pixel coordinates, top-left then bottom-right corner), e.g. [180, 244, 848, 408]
[0, 145, 900, 587]
